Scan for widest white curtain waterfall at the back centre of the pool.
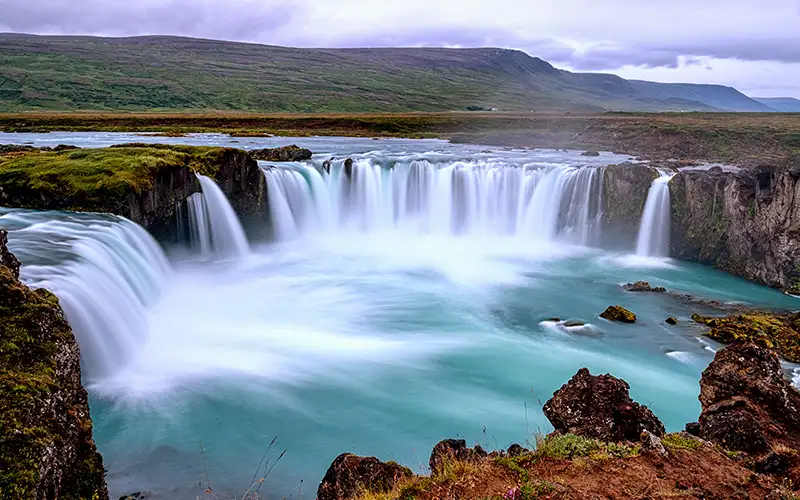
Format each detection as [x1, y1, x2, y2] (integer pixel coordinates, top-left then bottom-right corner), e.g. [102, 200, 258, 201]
[260, 158, 603, 245]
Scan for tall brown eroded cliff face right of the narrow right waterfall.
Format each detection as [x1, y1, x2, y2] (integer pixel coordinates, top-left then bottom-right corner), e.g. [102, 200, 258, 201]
[669, 167, 800, 292]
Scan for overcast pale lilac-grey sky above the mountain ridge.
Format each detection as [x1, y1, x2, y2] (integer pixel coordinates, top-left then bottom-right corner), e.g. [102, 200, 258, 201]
[0, 0, 800, 98]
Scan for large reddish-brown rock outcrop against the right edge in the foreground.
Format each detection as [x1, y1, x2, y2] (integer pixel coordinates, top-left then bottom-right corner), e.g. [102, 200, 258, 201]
[700, 343, 800, 454]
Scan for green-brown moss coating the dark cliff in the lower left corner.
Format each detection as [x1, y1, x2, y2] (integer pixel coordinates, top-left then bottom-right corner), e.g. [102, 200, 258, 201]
[0, 266, 104, 500]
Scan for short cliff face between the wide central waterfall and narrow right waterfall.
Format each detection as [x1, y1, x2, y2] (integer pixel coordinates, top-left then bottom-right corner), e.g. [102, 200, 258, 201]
[602, 163, 658, 250]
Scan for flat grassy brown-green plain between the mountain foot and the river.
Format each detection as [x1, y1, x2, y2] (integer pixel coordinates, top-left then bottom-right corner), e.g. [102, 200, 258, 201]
[0, 112, 800, 166]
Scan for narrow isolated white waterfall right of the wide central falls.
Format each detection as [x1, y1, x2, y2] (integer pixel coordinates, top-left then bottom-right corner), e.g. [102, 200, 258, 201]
[636, 170, 675, 257]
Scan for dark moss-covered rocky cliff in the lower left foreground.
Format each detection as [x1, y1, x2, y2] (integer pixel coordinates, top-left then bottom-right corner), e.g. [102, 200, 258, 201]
[0, 230, 108, 500]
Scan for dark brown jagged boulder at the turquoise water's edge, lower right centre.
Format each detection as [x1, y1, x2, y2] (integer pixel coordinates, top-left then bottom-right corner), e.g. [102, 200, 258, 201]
[543, 368, 664, 442]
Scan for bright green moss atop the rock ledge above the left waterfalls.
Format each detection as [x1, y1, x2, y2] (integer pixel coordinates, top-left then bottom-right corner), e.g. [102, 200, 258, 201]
[0, 144, 234, 211]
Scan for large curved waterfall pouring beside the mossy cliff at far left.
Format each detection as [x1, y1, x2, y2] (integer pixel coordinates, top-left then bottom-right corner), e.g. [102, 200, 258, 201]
[0, 210, 172, 379]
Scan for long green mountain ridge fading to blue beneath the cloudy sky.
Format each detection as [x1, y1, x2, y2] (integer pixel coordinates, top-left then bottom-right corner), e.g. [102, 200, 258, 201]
[0, 34, 772, 112]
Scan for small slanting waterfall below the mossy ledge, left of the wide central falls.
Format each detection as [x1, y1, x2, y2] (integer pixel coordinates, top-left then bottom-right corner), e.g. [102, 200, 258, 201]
[187, 174, 250, 257]
